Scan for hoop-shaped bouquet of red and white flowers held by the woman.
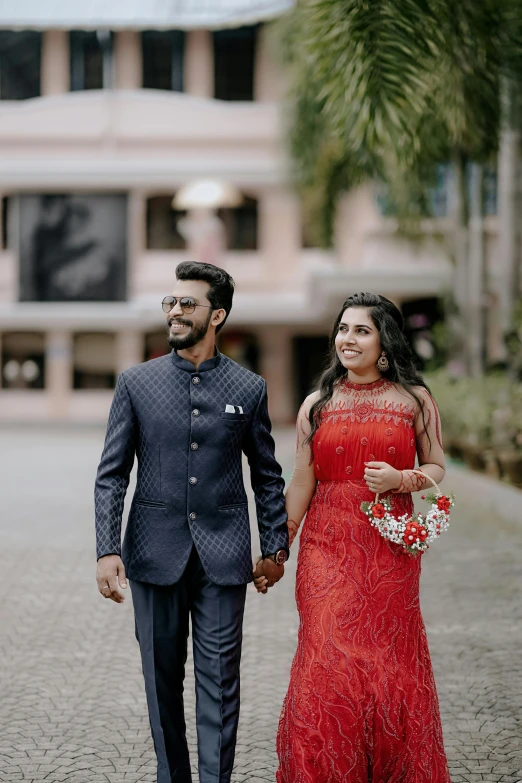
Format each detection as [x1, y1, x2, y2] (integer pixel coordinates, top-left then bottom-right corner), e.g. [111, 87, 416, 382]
[361, 476, 455, 555]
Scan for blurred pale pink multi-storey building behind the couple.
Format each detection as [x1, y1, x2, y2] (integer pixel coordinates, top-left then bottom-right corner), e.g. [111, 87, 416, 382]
[0, 0, 464, 422]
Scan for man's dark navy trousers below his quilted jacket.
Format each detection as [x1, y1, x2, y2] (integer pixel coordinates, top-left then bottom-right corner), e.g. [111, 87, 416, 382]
[131, 548, 246, 783]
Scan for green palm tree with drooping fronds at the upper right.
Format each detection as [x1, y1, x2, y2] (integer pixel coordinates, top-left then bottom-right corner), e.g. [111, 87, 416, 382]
[278, 0, 522, 374]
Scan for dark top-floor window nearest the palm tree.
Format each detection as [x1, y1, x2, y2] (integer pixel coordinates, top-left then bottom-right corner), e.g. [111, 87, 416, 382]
[214, 27, 258, 101]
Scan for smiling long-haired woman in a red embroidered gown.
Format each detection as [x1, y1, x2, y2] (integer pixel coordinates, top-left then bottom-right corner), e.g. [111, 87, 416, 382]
[256, 294, 450, 783]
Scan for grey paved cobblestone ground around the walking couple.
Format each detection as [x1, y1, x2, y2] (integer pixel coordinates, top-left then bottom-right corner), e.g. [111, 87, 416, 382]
[0, 428, 522, 783]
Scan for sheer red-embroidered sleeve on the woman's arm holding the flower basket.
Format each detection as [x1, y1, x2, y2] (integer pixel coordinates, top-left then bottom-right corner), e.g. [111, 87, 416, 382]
[396, 388, 446, 492]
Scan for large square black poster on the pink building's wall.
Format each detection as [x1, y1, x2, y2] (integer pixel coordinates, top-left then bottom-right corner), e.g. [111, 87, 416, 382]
[19, 194, 127, 302]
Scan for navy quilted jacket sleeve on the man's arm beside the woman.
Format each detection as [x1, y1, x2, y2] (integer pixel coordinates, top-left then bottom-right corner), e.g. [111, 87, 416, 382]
[243, 381, 289, 556]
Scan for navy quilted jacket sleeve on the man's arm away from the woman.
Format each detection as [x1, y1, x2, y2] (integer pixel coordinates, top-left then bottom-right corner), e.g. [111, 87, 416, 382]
[94, 375, 137, 559]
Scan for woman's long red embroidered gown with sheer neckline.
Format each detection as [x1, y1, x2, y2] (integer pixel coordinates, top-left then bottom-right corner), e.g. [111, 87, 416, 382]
[277, 381, 450, 783]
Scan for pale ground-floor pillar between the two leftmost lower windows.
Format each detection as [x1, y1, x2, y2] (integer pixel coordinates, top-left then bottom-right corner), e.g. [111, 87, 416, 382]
[45, 331, 73, 419]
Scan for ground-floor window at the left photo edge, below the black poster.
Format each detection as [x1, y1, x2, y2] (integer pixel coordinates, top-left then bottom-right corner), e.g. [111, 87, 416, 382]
[2, 332, 45, 389]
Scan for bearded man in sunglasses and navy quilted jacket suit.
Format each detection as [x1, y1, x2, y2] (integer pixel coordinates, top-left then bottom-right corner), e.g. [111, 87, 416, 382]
[95, 262, 288, 783]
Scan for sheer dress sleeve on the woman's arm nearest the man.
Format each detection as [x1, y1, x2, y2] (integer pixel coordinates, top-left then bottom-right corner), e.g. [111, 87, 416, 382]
[286, 392, 318, 545]
